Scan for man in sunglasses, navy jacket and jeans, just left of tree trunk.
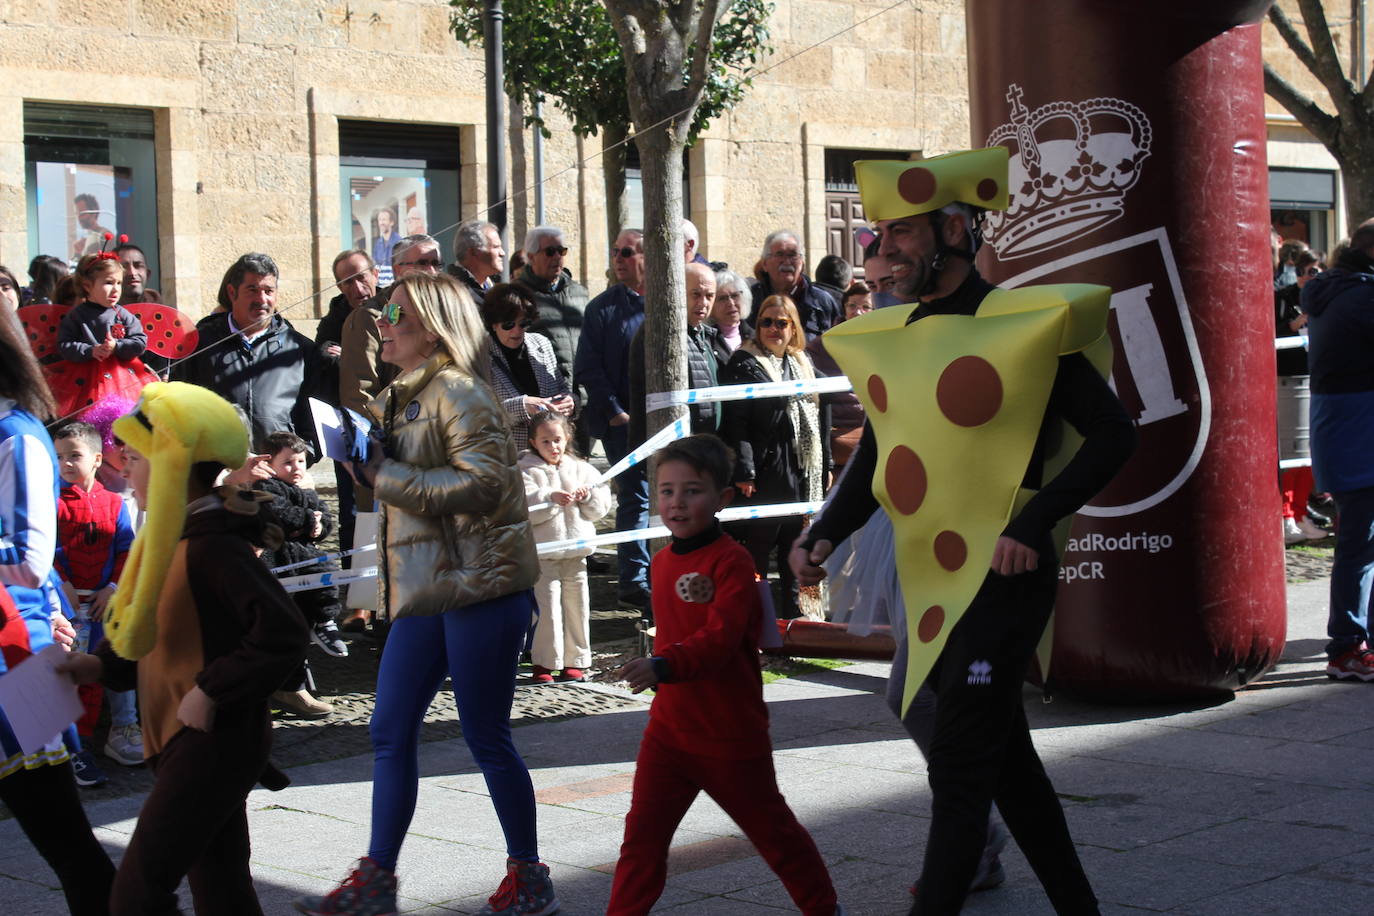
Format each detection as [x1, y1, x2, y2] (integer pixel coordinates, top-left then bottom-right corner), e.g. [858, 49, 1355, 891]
[573, 229, 649, 610]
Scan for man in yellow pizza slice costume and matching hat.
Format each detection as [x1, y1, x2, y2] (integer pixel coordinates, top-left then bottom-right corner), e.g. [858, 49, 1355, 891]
[793, 147, 1135, 913]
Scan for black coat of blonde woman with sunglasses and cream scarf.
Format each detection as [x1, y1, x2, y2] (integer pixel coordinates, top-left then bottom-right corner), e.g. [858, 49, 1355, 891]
[721, 347, 830, 503]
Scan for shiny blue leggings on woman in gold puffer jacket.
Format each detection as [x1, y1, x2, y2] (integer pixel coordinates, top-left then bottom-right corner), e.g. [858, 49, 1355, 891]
[367, 591, 539, 871]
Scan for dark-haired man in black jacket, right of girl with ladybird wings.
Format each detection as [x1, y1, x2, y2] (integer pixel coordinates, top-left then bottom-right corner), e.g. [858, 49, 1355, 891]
[172, 253, 322, 449]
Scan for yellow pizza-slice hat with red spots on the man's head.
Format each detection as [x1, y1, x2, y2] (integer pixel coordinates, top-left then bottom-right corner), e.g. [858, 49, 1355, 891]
[855, 147, 1007, 224]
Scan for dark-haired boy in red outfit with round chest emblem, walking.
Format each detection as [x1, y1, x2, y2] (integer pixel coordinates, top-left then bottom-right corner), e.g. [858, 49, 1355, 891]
[606, 434, 844, 916]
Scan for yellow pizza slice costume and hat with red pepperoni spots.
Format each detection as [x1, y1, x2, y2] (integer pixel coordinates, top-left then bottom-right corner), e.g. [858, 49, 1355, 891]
[826, 147, 1112, 710]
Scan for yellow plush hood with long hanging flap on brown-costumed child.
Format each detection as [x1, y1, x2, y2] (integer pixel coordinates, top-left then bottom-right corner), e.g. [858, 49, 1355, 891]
[106, 382, 249, 659]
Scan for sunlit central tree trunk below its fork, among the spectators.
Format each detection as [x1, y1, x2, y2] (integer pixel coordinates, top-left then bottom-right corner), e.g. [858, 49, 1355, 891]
[635, 128, 687, 433]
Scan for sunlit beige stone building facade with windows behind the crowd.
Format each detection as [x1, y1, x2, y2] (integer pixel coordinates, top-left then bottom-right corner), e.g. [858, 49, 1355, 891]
[0, 0, 1348, 321]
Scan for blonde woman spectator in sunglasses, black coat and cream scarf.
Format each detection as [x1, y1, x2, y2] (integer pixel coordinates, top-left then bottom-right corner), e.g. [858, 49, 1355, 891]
[721, 295, 830, 618]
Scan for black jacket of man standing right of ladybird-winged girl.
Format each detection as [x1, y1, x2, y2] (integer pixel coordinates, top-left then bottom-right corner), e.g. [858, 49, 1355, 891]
[172, 312, 324, 455]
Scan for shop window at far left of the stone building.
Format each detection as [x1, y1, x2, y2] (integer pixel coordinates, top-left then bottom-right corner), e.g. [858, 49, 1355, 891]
[16, 102, 161, 276]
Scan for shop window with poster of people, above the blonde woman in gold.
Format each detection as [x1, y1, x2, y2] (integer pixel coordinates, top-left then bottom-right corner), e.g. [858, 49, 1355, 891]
[339, 118, 459, 286]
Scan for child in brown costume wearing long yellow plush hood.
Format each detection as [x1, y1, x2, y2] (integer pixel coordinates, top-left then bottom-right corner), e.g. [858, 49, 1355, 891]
[66, 382, 308, 916]
